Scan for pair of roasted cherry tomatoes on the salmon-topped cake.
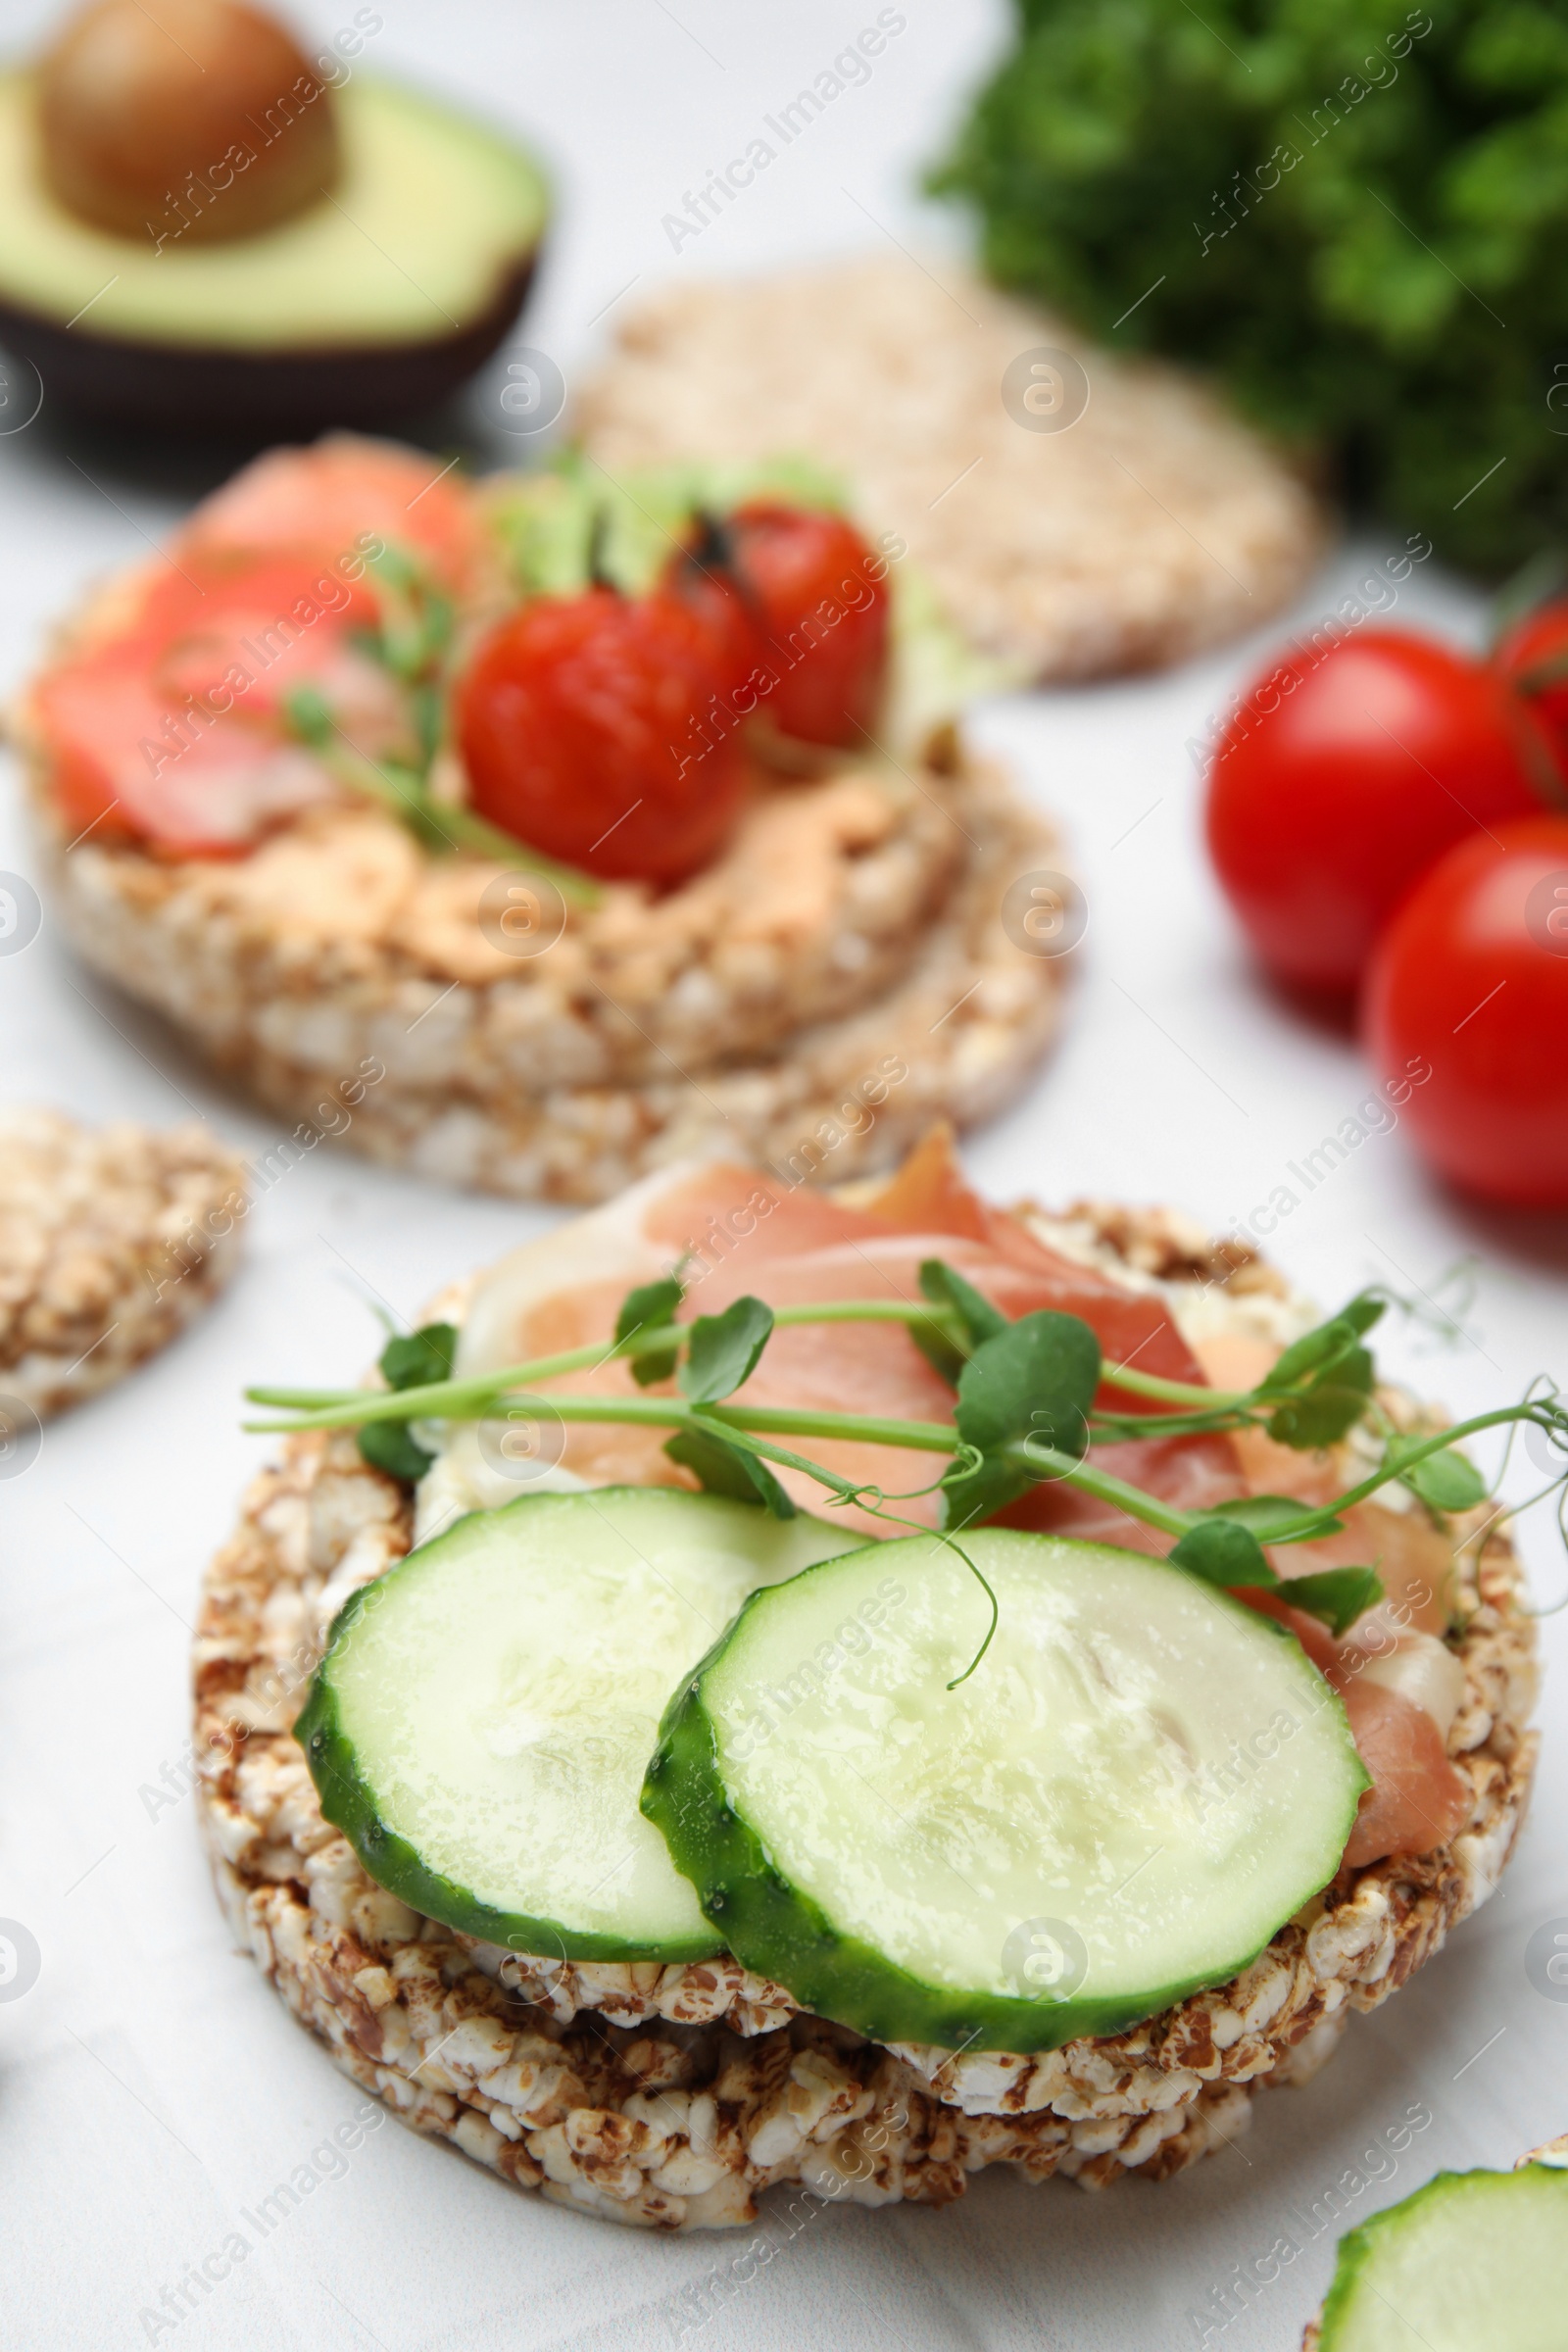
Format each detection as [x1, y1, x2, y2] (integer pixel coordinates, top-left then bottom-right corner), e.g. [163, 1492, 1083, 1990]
[456, 501, 891, 887]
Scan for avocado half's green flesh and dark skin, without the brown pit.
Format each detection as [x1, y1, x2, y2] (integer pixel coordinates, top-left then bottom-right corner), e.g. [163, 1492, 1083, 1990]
[0, 71, 548, 437]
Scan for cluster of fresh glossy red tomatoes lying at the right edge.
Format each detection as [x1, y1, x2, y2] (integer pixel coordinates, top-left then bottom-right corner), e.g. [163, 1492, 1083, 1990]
[1208, 602, 1568, 1206]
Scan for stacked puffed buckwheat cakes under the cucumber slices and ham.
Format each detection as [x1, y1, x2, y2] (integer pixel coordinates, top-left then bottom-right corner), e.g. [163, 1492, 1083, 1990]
[195, 1204, 1535, 2230]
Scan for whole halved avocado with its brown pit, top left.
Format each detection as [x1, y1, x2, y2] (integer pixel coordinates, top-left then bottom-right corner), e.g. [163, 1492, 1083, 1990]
[0, 0, 548, 445]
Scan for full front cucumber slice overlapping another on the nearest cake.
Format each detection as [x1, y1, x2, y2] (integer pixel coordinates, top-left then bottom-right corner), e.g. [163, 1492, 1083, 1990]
[642, 1529, 1368, 2051]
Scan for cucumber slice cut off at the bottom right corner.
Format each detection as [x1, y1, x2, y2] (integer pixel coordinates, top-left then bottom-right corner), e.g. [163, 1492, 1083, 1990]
[1319, 2164, 1568, 2352]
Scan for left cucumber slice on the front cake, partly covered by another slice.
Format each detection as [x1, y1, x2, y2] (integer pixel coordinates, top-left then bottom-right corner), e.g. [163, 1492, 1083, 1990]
[294, 1487, 862, 1959]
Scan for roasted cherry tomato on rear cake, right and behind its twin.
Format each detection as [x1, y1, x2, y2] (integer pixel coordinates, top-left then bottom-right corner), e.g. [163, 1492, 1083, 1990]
[724, 499, 891, 746]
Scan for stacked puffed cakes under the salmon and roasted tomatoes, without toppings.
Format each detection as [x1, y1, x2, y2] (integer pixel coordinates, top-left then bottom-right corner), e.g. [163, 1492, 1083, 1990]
[27, 755, 1065, 1201]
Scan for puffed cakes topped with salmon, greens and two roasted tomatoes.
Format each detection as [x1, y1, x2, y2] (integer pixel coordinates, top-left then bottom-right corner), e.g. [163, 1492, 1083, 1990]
[12, 435, 1081, 1200]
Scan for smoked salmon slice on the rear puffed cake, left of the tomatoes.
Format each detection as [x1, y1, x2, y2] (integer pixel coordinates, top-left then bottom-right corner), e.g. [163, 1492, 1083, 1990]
[30, 435, 482, 857]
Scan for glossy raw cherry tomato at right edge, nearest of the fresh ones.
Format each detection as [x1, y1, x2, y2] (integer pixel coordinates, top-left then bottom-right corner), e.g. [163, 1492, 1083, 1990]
[1366, 816, 1568, 1209]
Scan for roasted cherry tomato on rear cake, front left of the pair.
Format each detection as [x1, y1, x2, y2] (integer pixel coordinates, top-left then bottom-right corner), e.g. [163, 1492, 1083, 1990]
[456, 588, 743, 884]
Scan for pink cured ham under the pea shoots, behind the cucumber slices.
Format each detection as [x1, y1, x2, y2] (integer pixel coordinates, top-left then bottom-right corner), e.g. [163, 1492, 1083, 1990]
[472, 1141, 1469, 1865]
